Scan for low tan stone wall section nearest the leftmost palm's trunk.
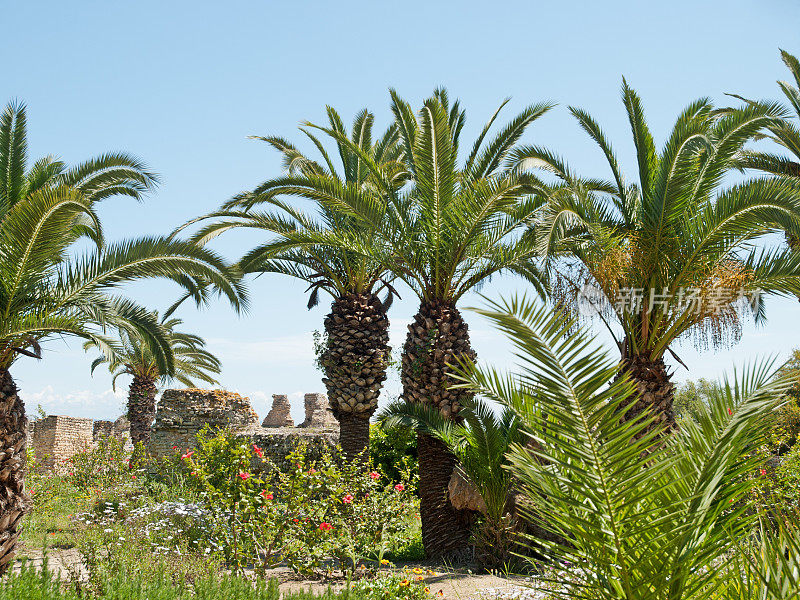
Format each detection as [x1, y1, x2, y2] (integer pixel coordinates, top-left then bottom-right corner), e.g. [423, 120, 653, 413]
[31, 415, 93, 471]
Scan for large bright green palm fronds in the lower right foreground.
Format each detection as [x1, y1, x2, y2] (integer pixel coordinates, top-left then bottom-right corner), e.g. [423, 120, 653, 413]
[456, 298, 800, 600]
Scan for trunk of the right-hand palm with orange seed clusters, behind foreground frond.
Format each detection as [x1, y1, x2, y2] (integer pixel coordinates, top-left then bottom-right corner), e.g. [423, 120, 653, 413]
[620, 356, 676, 432]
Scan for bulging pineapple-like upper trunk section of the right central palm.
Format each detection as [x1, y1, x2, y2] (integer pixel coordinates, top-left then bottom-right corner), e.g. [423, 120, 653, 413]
[402, 302, 476, 418]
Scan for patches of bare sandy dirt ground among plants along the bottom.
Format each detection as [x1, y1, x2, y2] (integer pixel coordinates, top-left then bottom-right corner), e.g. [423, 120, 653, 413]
[14, 548, 546, 600]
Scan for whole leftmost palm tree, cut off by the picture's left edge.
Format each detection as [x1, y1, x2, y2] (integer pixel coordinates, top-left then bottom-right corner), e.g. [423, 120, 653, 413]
[0, 104, 243, 574]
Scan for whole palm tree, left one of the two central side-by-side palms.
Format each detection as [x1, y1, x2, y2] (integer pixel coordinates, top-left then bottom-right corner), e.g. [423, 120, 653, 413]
[184, 107, 404, 459]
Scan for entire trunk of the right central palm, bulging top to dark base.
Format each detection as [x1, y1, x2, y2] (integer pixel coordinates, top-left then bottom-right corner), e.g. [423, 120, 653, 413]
[401, 302, 476, 558]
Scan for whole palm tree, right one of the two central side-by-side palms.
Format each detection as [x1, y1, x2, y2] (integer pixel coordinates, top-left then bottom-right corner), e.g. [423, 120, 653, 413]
[318, 89, 552, 556]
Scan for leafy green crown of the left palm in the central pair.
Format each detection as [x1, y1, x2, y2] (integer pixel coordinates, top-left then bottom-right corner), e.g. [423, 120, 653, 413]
[187, 107, 405, 307]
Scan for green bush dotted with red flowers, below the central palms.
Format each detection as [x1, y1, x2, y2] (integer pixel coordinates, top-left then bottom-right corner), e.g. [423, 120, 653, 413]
[181, 431, 416, 573]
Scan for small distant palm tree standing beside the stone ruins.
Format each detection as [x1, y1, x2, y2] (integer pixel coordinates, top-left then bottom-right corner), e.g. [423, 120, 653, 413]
[84, 314, 220, 444]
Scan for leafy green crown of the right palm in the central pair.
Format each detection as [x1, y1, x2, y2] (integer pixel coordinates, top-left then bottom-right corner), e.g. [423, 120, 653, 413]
[327, 90, 551, 302]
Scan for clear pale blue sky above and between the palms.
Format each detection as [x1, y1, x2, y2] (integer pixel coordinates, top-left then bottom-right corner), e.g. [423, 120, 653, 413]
[0, 0, 800, 418]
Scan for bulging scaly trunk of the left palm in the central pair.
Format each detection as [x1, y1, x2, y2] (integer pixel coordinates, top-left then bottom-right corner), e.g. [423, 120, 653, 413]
[321, 294, 390, 461]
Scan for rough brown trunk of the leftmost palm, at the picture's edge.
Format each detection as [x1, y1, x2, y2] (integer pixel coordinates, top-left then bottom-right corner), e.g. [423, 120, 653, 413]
[0, 369, 28, 575]
